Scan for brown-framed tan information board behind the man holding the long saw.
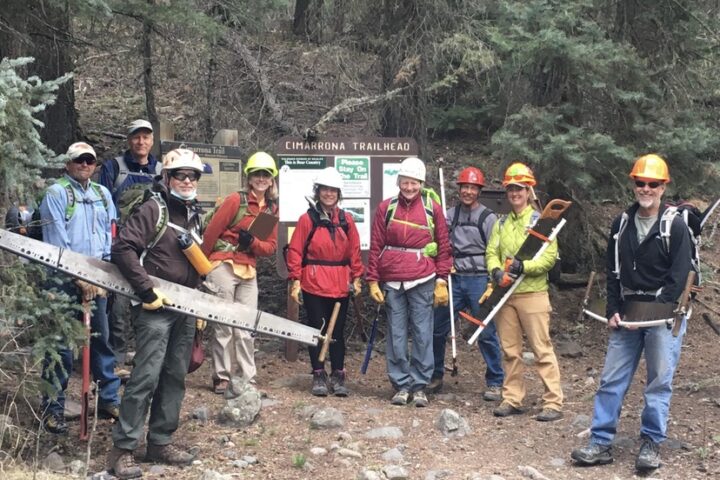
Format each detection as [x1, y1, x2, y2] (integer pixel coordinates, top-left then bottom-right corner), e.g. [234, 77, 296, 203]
[160, 141, 243, 208]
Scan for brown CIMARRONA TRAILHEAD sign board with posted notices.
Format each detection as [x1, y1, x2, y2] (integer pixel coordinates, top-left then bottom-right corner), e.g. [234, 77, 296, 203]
[275, 137, 419, 278]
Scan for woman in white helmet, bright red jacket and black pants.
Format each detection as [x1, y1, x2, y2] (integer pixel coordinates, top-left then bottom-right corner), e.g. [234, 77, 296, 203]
[287, 167, 363, 397]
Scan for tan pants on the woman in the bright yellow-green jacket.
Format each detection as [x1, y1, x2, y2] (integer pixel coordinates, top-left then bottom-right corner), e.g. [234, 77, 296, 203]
[496, 292, 563, 410]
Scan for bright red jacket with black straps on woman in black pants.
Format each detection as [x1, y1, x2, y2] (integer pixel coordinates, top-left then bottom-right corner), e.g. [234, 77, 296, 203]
[287, 207, 364, 298]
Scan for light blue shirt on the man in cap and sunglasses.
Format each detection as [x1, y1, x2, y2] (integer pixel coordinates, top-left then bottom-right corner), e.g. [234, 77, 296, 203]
[40, 175, 117, 260]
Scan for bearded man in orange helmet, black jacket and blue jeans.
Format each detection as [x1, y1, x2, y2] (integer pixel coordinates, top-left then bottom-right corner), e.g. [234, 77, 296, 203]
[571, 154, 691, 471]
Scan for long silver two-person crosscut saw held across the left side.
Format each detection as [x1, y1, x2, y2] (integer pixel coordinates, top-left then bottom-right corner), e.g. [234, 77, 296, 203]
[0, 229, 325, 346]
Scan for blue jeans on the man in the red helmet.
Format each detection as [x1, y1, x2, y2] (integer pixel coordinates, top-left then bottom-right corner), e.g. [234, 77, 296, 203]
[432, 275, 504, 387]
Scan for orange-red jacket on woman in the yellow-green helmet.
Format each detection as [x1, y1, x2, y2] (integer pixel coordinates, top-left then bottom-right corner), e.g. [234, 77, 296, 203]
[202, 192, 277, 267]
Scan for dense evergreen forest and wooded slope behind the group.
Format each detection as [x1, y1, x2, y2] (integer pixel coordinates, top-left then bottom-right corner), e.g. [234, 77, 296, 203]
[0, 0, 720, 474]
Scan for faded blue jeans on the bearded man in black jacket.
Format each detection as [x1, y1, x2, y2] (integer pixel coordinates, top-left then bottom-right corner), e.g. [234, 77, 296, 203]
[590, 320, 687, 445]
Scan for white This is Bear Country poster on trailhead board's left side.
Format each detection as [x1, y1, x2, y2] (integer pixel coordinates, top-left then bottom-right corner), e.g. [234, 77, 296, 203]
[279, 156, 327, 222]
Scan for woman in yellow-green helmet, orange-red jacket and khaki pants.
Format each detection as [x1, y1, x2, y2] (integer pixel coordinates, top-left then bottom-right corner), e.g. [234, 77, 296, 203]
[203, 152, 278, 394]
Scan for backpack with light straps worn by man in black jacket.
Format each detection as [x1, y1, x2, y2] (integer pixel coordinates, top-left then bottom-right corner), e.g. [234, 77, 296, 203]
[613, 200, 708, 286]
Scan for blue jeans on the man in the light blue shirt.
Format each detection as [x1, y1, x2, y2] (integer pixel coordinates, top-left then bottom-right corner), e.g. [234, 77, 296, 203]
[42, 297, 120, 415]
